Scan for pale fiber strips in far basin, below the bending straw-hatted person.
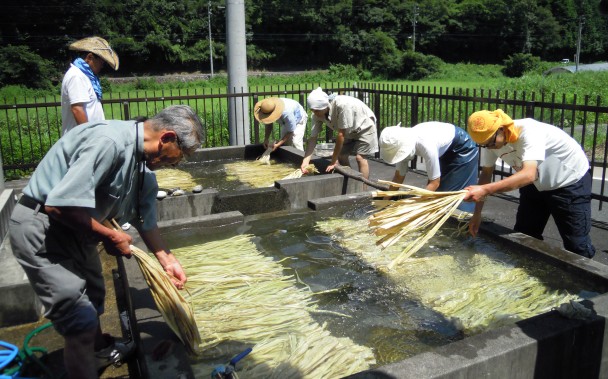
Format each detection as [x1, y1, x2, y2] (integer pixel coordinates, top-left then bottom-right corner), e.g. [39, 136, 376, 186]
[224, 160, 294, 188]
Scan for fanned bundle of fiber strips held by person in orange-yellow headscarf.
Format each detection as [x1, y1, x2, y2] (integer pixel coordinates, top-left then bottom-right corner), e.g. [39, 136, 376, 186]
[369, 180, 467, 269]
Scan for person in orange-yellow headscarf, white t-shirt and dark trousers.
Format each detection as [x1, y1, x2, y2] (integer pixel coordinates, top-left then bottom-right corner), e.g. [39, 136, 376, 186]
[465, 109, 595, 258]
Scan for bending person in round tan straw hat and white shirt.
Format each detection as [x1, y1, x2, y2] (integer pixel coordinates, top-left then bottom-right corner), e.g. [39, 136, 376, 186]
[253, 97, 308, 151]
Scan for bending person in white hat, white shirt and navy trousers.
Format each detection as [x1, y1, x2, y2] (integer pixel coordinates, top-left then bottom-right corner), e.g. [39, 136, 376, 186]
[380, 121, 479, 213]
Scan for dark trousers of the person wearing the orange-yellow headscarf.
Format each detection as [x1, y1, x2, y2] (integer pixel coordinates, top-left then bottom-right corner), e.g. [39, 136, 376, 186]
[514, 172, 595, 258]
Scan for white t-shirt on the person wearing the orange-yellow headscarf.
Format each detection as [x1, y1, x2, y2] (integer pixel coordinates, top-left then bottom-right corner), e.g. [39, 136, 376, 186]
[480, 118, 589, 191]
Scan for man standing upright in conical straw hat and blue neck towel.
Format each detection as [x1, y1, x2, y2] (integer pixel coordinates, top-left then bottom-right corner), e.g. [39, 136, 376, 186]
[61, 37, 119, 134]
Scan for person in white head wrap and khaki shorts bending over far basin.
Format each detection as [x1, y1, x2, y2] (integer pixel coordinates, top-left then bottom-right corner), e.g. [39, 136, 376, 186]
[300, 87, 378, 179]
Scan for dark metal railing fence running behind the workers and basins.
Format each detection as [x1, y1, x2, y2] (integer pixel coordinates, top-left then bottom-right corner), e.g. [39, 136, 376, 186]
[0, 83, 608, 209]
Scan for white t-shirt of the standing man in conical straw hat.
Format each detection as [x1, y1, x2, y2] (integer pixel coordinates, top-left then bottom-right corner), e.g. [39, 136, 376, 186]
[61, 64, 106, 134]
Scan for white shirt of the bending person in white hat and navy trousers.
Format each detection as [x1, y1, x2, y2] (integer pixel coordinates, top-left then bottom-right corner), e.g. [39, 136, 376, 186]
[395, 121, 456, 180]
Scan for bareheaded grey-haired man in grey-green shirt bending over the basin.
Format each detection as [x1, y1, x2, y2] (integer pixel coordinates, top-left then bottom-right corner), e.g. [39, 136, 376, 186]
[9, 105, 203, 378]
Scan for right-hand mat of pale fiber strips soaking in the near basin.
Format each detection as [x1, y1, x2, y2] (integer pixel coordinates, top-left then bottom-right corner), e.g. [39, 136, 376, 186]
[315, 218, 581, 333]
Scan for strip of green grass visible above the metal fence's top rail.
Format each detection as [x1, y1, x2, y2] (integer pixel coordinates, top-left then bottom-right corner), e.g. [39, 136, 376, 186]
[0, 62, 608, 105]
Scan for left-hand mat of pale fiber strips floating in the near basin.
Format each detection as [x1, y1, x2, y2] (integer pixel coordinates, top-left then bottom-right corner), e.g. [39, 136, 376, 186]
[173, 235, 375, 378]
